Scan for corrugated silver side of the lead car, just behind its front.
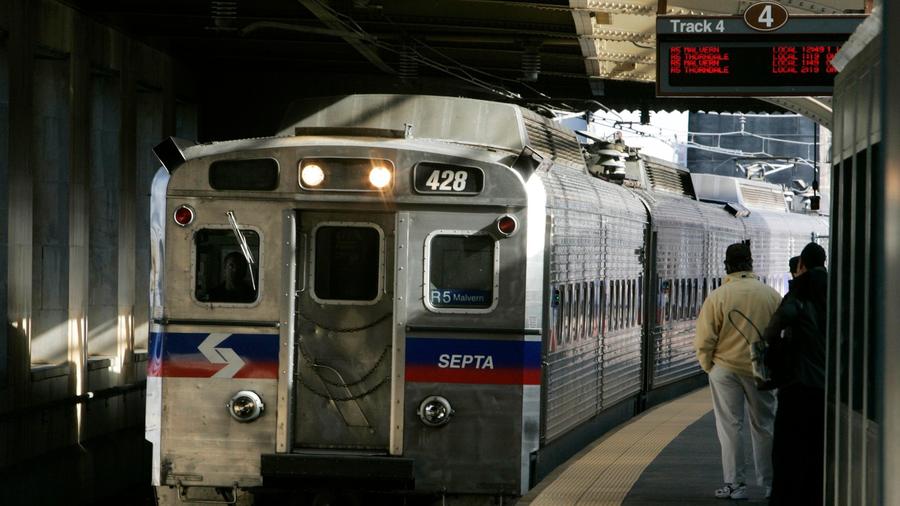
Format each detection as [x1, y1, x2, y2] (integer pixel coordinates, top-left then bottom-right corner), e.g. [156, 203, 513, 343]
[541, 166, 647, 441]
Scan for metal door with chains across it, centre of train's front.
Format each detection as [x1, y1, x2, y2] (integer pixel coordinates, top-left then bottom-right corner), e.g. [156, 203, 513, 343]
[293, 212, 394, 450]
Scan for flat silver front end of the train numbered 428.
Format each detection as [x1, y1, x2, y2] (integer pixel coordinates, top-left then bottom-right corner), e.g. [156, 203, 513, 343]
[146, 97, 545, 504]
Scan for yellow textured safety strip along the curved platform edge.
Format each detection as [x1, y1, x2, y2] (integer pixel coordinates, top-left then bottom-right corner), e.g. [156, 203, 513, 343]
[518, 387, 712, 506]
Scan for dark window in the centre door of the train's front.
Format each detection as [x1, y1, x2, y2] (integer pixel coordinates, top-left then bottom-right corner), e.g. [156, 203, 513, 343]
[313, 223, 382, 303]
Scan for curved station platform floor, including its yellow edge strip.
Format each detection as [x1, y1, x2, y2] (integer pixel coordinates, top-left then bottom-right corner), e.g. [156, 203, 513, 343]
[516, 387, 768, 506]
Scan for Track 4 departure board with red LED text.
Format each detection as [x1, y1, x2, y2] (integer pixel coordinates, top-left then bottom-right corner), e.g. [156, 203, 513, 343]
[657, 16, 862, 96]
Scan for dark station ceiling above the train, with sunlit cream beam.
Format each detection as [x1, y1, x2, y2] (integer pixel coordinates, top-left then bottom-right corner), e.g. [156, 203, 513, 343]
[67, 0, 872, 112]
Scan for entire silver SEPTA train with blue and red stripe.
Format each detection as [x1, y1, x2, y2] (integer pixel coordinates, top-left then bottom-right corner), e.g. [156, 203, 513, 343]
[146, 95, 827, 504]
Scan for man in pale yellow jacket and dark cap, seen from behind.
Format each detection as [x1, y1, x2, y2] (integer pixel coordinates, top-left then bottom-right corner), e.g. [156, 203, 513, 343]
[694, 243, 781, 499]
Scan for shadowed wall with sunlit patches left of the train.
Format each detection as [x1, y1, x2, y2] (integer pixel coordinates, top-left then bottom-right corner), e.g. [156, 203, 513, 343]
[0, 0, 198, 504]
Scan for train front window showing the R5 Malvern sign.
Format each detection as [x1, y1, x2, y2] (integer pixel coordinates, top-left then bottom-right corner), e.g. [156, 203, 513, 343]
[425, 233, 499, 313]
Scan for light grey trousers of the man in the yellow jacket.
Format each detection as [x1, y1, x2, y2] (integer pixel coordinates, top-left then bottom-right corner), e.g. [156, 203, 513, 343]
[709, 366, 777, 487]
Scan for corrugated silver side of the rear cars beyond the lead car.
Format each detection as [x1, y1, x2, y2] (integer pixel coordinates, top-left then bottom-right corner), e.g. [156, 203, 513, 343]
[644, 188, 828, 386]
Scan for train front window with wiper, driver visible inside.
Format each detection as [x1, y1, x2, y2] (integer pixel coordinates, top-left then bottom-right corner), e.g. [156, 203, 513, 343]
[194, 229, 259, 304]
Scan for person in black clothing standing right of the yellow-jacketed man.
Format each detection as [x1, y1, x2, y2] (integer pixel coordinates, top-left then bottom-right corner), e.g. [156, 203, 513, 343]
[763, 243, 828, 505]
